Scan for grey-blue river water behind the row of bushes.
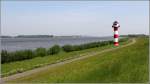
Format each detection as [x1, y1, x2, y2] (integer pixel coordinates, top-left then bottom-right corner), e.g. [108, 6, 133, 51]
[1, 37, 113, 51]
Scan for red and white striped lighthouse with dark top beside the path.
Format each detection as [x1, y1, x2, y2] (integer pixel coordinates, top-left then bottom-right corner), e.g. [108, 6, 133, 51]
[112, 21, 120, 46]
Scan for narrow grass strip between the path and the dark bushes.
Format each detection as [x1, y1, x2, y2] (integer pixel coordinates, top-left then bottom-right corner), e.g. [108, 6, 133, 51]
[1, 38, 128, 77]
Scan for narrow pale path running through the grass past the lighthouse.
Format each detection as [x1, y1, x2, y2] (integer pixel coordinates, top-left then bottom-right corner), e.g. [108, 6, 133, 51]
[1, 39, 136, 82]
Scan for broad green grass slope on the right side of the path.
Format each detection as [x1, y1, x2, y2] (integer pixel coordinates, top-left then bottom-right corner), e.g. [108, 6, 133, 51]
[9, 38, 149, 83]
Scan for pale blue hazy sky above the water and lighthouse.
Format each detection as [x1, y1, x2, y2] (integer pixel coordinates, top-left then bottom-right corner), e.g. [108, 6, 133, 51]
[1, 1, 149, 36]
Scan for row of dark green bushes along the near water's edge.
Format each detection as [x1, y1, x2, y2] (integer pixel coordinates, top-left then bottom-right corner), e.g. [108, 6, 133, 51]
[1, 38, 127, 64]
